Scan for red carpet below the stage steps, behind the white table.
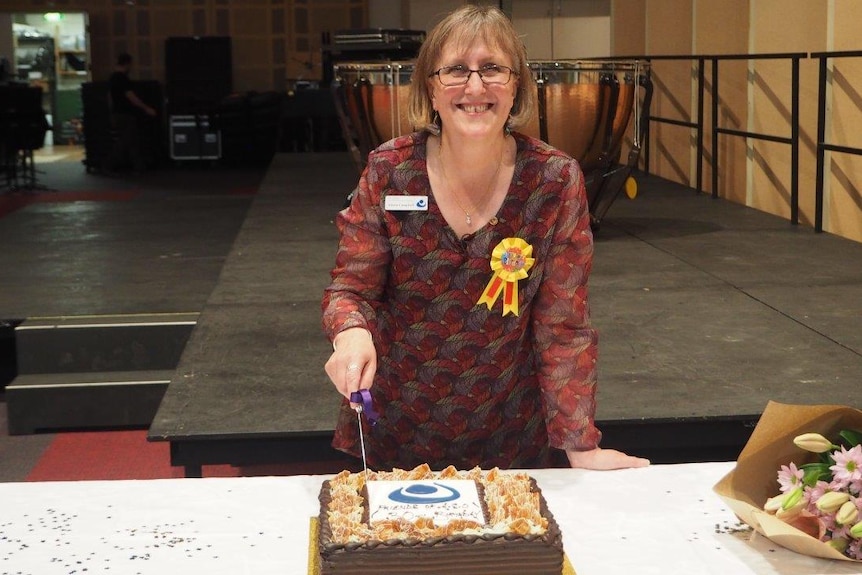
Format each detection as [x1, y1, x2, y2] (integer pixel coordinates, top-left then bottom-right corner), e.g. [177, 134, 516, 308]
[27, 429, 352, 481]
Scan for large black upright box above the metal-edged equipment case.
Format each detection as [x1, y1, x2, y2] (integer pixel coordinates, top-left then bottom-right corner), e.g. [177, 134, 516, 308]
[165, 36, 233, 114]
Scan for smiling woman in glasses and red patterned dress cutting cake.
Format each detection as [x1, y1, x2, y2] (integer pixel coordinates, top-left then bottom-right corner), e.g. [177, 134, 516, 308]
[323, 6, 649, 469]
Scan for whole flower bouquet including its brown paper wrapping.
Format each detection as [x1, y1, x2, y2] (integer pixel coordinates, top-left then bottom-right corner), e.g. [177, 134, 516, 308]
[713, 402, 862, 561]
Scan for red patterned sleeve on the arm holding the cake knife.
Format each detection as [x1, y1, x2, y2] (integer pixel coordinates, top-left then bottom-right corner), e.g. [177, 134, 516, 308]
[322, 154, 392, 341]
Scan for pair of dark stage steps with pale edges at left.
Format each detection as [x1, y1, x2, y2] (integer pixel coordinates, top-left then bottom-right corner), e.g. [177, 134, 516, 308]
[5, 313, 199, 435]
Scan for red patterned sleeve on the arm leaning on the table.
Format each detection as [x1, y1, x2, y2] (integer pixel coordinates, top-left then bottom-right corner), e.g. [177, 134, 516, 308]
[533, 155, 601, 451]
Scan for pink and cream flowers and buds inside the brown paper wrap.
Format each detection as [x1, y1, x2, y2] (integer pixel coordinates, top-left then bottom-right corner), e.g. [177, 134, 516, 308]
[763, 429, 862, 560]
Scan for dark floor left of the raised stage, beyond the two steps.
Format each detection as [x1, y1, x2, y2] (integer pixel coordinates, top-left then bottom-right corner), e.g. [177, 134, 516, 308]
[0, 155, 265, 319]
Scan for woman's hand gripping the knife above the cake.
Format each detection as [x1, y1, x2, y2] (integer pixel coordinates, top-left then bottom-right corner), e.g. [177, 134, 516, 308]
[324, 327, 377, 399]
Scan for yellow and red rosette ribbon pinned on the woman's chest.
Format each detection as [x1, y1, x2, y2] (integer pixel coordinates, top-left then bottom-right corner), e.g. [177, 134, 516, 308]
[476, 238, 536, 315]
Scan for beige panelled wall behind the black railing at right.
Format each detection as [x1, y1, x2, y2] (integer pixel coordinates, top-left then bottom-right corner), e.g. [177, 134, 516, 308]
[612, 0, 862, 241]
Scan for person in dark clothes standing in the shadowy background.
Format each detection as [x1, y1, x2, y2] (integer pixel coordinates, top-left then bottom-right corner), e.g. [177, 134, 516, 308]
[108, 52, 156, 172]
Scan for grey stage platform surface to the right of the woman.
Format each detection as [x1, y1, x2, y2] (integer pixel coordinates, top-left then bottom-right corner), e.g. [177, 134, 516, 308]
[591, 179, 862, 419]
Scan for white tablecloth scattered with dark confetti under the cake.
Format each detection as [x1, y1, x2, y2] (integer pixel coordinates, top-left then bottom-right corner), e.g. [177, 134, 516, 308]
[0, 463, 862, 575]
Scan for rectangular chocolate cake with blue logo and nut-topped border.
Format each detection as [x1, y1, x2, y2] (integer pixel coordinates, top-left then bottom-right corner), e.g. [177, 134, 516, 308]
[318, 465, 563, 575]
